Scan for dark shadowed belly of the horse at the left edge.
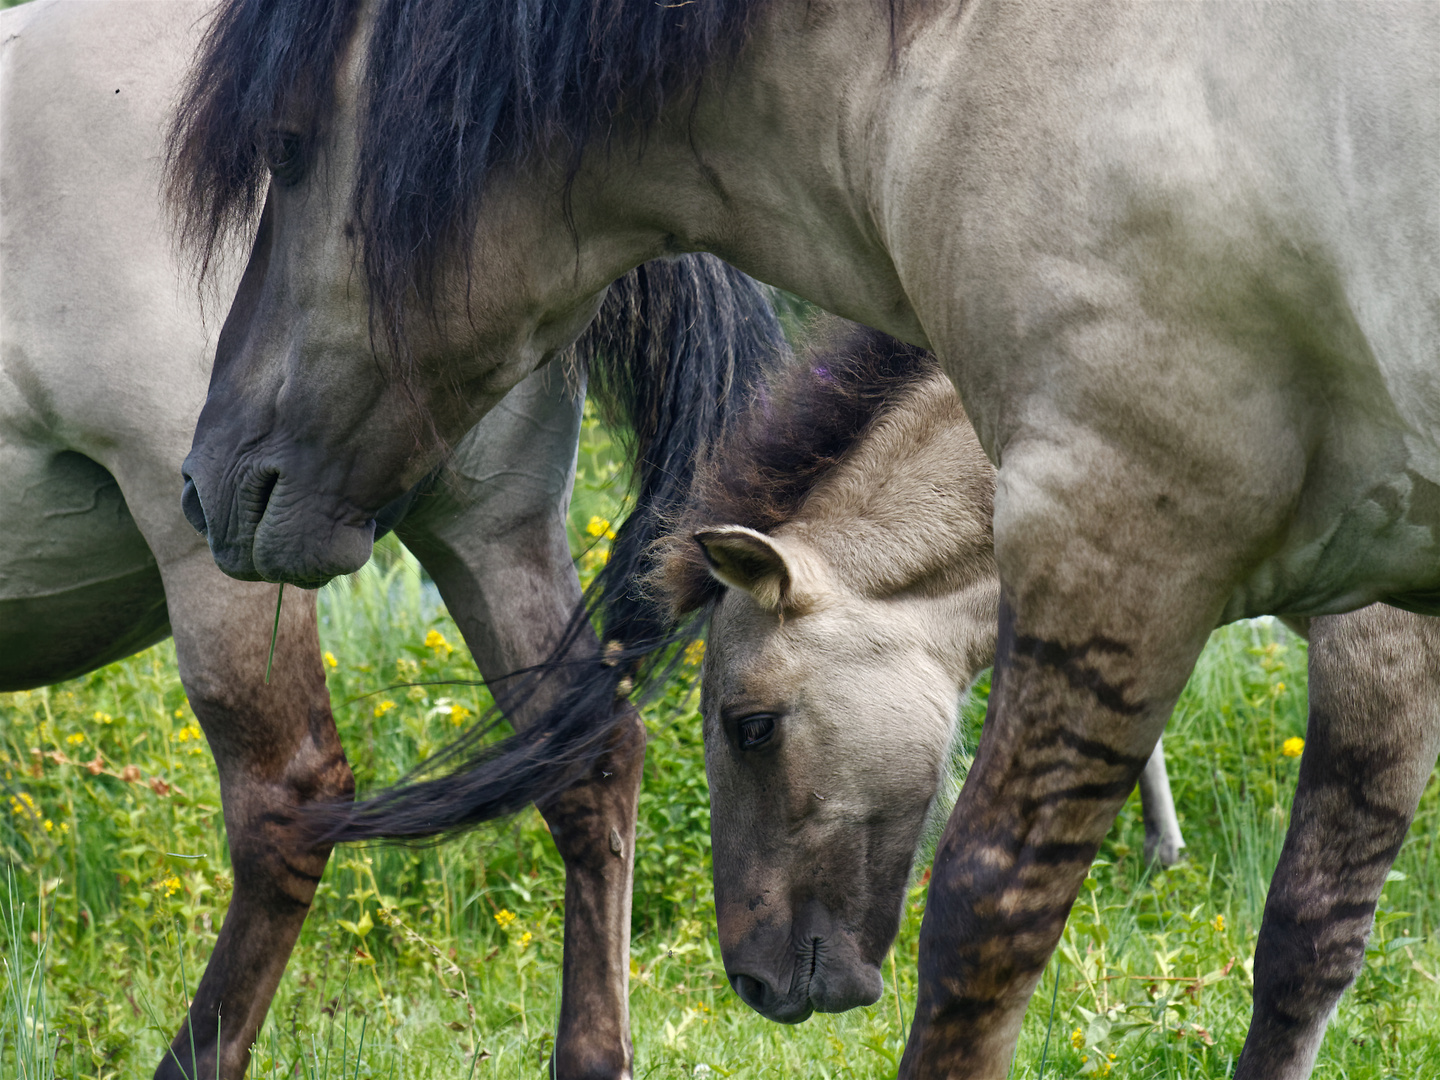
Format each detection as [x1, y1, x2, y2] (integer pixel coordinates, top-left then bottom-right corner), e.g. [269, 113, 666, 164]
[0, 446, 170, 691]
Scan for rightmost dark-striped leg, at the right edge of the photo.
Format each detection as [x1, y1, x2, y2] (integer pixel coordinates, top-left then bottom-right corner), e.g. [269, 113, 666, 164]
[1236, 605, 1440, 1080]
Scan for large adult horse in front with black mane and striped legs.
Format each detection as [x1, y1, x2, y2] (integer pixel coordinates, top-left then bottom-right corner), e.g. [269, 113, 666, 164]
[170, 0, 1440, 1080]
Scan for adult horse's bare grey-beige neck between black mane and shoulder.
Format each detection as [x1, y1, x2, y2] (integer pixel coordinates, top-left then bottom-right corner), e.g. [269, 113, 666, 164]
[576, 0, 926, 346]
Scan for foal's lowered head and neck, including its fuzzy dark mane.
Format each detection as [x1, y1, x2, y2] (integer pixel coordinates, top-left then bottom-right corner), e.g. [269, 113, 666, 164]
[655, 330, 998, 1022]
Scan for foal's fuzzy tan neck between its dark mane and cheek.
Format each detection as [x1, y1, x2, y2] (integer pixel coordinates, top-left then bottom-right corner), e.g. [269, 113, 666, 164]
[785, 374, 999, 685]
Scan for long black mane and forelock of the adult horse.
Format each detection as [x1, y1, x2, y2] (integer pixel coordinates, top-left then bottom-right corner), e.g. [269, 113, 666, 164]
[167, 0, 765, 348]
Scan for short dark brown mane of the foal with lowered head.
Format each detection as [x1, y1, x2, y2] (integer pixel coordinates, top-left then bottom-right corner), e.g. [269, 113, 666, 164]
[649, 318, 940, 618]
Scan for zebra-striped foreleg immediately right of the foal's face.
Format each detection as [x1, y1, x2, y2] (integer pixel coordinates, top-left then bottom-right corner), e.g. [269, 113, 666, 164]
[900, 587, 1205, 1080]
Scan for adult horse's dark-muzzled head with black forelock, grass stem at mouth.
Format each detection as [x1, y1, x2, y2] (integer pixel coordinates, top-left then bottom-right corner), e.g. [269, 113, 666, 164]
[168, 0, 835, 585]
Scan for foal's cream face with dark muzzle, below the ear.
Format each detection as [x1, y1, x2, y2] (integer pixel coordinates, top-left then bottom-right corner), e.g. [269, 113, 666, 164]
[701, 529, 960, 1022]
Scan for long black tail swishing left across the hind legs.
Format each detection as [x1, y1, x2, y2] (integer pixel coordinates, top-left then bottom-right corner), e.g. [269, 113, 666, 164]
[307, 255, 788, 842]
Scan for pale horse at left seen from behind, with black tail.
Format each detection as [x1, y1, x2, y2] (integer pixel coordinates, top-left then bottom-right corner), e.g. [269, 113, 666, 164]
[0, 0, 783, 1080]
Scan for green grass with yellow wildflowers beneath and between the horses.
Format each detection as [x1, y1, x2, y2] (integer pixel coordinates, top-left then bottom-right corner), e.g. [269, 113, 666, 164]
[0, 403, 1440, 1080]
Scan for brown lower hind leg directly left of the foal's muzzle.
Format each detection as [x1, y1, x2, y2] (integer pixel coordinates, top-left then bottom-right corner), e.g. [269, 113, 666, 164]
[540, 703, 645, 1080]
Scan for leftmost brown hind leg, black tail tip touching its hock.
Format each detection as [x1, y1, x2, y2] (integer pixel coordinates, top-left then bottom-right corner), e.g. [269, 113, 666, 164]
[156, 550, 354, 1080]
